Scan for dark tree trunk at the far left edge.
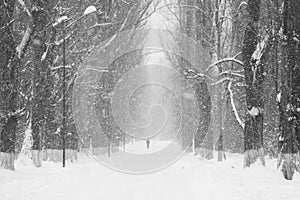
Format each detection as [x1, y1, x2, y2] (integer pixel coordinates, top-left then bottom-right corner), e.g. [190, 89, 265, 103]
[0, 0, 19, 170]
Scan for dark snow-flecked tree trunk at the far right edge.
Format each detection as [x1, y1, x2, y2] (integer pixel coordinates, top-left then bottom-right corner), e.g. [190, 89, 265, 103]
[278, 0, 300, 180]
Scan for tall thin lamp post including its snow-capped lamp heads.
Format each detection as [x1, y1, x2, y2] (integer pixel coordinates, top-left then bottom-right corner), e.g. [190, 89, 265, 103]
[60, 6, 97, 167]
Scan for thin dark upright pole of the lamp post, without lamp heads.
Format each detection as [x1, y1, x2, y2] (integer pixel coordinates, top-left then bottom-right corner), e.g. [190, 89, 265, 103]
[62, 21, 66, 167]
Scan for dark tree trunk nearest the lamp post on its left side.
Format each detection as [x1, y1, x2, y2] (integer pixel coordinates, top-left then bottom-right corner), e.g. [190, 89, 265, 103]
[32, 1, 48, 167]
